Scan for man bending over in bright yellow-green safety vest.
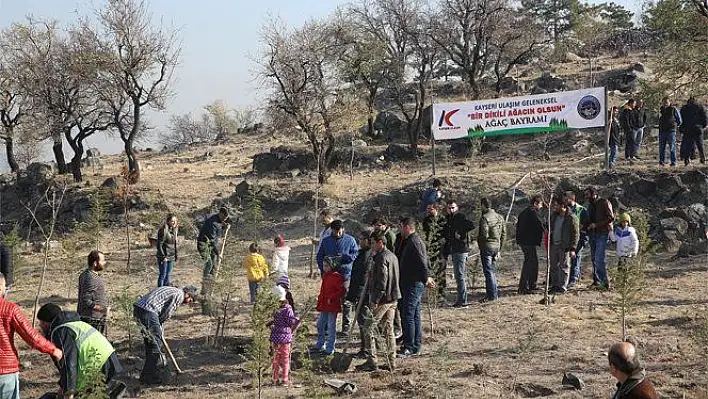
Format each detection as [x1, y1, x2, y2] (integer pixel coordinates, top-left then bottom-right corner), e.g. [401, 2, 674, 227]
[37, 303, 126, 399]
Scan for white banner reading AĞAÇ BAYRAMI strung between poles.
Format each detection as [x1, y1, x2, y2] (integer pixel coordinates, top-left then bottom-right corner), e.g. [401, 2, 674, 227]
[432, 87, 607, 140]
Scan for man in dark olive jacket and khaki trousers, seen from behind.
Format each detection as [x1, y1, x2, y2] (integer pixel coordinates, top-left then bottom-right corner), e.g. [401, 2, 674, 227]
[357, 231, 401, 371]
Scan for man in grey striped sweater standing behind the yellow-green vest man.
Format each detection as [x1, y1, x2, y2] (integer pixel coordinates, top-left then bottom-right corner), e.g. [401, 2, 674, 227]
[76, 251, 108, 334]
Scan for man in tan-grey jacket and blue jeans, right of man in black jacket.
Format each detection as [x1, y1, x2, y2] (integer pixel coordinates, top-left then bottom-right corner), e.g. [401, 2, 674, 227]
[477, 198, 506, 303]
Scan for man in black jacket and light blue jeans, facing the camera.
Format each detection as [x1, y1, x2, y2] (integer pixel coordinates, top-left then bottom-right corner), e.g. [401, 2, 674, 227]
[443, 201, 475, 308]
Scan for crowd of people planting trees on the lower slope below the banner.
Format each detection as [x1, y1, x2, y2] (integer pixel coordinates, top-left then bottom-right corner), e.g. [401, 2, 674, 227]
[0, 179, 657, 399]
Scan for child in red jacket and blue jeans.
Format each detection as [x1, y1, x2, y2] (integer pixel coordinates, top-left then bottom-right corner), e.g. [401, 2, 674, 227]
[315, 257, 346, 356]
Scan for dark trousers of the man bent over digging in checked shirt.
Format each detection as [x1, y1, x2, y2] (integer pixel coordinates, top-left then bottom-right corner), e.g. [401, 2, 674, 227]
[133, 306, 168, 382]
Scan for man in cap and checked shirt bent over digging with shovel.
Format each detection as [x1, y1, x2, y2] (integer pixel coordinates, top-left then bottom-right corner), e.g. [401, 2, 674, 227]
[133, 285, 197, 384]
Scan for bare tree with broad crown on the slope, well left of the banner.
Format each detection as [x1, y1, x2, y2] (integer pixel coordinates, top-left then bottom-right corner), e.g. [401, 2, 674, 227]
[260, 21, 349, 183]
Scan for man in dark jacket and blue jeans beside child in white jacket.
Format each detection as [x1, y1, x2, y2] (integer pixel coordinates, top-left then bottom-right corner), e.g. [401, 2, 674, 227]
[585, 187, 615, 289]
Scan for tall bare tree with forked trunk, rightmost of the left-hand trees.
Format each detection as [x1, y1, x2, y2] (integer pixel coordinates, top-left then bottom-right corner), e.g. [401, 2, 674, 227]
[98, 0, 180, 181]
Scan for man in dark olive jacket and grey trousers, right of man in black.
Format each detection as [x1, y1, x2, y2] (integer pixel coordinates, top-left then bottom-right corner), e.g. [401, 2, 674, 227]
[548, 197, 580, 294]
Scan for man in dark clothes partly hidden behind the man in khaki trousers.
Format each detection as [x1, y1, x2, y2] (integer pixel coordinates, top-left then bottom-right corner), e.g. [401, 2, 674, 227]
[346, 229, 373, 358]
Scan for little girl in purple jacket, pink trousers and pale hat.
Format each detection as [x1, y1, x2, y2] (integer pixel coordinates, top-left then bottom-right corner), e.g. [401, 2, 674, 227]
[268, 285, 300, 385]
